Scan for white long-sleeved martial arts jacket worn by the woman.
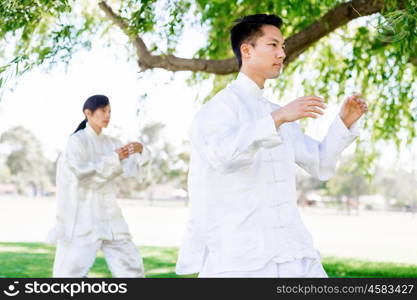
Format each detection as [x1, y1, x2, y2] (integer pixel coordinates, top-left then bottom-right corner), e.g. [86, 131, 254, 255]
[47, 123, 149, 244]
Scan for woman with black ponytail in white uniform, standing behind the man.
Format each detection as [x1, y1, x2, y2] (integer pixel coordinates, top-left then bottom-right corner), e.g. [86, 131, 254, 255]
[47, 95, 146, 277]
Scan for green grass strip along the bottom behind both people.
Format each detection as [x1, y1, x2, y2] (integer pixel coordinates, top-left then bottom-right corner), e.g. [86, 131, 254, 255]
[0, 243, 417, 278]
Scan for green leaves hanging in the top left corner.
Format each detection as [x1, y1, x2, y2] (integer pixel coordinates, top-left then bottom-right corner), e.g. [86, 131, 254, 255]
[0, 0, 95, 83]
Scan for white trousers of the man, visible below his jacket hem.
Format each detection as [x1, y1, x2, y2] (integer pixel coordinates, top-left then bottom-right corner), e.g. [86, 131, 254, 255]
[198, 258, 328, 278]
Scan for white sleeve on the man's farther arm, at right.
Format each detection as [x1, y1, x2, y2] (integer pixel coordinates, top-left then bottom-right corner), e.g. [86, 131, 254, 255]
[293, 115, 359, 181]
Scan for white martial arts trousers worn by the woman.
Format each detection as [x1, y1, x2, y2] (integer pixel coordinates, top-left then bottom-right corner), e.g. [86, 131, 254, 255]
[53, 239, 145, 278]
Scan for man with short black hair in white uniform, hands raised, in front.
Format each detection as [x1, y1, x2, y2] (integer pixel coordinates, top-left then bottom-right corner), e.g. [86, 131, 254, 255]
[176, 15, 367, 277]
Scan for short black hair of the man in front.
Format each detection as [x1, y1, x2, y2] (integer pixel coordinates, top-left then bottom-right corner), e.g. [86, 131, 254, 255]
[230, 14, 282, 69]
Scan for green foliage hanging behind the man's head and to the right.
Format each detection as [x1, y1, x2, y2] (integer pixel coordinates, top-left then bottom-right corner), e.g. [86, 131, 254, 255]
[196, 0, 417, 150]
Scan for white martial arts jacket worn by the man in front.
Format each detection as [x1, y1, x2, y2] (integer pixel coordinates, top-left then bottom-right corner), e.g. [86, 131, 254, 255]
[176, 73, 358, 274]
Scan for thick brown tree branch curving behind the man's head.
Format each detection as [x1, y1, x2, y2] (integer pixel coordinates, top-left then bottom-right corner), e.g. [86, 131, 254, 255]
[99, 0, 384, 75]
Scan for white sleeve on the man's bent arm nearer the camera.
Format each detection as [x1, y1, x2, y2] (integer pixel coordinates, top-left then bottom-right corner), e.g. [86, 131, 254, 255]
[190, 101, 282, 173]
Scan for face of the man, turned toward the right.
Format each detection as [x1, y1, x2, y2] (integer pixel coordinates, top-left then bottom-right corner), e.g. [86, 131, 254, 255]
[241, 25, 285, 79]
